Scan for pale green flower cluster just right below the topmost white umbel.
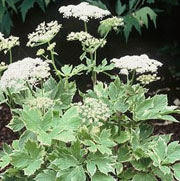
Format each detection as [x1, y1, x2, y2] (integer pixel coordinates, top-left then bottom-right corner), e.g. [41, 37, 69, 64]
[100, 16, 124, 31]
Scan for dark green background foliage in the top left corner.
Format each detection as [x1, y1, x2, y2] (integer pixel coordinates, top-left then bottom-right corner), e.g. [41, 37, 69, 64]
[0, 0, 54, 34]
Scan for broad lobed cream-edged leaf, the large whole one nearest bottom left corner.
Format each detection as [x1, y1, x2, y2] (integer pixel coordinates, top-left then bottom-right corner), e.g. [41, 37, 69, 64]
[11, 140, 45, 176]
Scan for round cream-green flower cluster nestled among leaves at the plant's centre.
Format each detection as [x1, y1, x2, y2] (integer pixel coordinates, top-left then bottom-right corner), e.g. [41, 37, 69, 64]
[75, 98, 111, 124]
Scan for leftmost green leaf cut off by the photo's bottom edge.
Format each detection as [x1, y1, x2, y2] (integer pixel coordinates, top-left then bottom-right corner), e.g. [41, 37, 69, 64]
[34, 170, 56, 181]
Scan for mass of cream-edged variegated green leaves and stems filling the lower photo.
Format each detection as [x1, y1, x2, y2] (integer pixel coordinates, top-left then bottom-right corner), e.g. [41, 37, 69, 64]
[0, 2, 180, 181]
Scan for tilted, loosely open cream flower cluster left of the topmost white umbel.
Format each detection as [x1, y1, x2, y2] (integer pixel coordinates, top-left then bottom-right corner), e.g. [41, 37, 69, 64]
[27, 21, 62, 47]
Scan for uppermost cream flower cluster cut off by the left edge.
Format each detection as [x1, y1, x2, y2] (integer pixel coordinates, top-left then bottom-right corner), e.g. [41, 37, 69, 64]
[0, 32, 20, 54]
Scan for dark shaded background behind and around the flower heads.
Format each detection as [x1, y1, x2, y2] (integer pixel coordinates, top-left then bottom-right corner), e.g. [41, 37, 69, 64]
[0, 0, 180, 146]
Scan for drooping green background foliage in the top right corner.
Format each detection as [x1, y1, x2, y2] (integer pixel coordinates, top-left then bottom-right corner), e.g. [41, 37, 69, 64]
[86, 0, 179, 41]
